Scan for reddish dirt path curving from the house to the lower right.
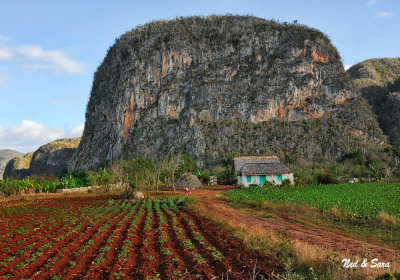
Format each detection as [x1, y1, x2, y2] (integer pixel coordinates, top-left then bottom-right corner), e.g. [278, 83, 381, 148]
[192, 186, 399, 262]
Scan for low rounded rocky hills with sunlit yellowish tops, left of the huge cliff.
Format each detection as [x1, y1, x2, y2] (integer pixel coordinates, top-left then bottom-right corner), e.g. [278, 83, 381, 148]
[4, 137, 81, 178]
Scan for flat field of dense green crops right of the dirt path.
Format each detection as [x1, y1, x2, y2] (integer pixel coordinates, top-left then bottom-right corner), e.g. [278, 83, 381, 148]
[227, 182, 400, 220]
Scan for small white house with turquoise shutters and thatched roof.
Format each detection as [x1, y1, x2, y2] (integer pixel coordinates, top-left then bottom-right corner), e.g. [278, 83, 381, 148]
[234, 156, 294, 187]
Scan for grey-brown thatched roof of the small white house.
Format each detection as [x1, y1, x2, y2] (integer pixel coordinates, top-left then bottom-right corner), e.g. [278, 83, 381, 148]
[234, 156, 290, 175]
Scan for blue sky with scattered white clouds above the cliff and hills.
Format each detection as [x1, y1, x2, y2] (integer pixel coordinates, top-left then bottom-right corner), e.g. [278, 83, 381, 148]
[0, 0, 400, 153]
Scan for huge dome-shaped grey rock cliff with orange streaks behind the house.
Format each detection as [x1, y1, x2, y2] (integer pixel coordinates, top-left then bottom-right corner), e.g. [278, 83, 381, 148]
[70, 16, 384, 170]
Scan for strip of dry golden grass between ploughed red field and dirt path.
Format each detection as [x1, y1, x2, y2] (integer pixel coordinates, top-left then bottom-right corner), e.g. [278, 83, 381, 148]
[188, 202, 394, 280]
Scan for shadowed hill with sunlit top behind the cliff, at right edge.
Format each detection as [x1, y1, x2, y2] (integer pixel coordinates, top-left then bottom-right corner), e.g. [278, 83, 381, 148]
[347, 58, 400, 146]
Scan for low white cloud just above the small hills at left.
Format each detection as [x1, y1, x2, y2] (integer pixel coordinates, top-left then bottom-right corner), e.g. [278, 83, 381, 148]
[0, 120, 84, 153]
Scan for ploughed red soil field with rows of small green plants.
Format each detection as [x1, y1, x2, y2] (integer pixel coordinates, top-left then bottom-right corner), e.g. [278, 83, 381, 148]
[0, 198, 282, 280]
